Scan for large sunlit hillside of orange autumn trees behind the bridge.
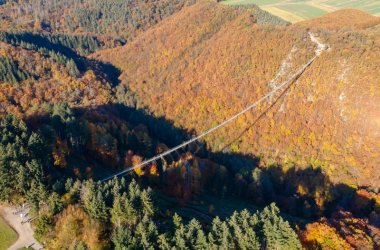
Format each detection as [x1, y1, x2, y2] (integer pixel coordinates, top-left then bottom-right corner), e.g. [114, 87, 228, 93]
[93, 2, 380, 187]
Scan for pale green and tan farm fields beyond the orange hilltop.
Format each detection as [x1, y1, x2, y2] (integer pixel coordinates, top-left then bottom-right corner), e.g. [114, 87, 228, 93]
[222, 0, 380, 23]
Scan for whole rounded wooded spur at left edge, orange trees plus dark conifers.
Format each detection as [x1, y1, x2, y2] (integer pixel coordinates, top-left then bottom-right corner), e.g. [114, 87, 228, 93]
[0, 40, 112, 117]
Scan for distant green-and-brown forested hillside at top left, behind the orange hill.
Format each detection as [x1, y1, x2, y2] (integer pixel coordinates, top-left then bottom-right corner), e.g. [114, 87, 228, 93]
[0, 0, 195, 40]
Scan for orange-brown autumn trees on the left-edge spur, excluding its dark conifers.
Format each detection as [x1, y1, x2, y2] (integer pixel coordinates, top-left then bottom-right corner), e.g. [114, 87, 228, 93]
[0, 43, 111, 116]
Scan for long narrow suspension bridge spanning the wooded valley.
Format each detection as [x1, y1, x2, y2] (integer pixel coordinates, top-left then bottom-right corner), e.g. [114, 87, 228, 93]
[100, 36, 321, 182]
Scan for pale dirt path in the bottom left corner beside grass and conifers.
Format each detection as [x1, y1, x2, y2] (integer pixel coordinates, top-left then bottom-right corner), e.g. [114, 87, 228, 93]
[0, 206, 43, 250]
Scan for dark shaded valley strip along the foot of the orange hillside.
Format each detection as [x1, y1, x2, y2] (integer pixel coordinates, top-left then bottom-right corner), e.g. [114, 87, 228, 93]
[63, 104, 380, 226]
